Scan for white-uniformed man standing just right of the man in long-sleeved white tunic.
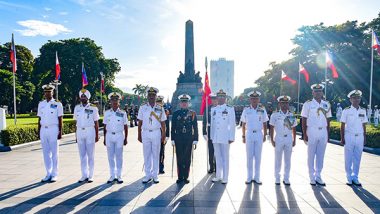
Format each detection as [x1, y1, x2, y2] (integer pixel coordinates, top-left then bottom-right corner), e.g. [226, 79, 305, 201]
[241, 91, 269, 184]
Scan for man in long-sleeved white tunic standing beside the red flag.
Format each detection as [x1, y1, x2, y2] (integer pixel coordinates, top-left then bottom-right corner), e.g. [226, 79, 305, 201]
[210, 89, 235, 184]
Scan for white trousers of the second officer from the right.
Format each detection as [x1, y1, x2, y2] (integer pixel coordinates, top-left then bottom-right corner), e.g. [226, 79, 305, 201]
[307, 127, 327, 180]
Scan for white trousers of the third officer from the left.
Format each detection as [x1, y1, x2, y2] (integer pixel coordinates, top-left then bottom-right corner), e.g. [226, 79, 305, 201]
[106, 131, 124, 178]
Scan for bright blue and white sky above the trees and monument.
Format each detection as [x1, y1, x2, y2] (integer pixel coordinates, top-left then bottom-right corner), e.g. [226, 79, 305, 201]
[0, 0, 380, 99]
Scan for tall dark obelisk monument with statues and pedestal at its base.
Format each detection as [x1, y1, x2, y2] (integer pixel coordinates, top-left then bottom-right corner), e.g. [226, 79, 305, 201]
[171, 20, 203, 114]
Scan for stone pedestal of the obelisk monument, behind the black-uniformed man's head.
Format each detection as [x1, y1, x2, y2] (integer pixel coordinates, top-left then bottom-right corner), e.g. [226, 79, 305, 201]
[171, 83, 203, 114]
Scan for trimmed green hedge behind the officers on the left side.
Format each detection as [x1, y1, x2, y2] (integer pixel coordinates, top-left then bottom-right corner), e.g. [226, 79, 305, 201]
[0, 119, 103, 146]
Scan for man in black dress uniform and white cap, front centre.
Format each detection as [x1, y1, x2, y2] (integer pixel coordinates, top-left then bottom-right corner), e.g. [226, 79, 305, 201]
[171, 94, 198, 184]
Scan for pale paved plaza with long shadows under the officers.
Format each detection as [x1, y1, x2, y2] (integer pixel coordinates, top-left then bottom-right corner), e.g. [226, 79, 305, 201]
[0, 123, 380, 214]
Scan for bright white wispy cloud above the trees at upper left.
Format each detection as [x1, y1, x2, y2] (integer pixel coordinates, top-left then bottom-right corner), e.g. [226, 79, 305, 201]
[17, 20, 71, 36]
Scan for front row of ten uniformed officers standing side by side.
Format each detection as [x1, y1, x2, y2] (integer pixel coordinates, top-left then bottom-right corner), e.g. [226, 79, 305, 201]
[38, 84, 368, 186]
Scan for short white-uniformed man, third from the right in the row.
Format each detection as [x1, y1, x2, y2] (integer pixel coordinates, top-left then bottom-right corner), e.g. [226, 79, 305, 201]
[269, 96, 297, 186]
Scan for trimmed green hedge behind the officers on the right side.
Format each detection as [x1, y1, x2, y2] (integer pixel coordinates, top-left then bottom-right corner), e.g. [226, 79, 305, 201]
[297, 118, 380, 148]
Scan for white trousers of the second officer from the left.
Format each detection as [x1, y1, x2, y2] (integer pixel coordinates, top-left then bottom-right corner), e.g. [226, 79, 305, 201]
[76, 127, 95, 178]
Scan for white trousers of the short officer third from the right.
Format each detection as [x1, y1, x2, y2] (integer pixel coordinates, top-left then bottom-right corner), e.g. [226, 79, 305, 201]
[274, 134, 293, 182]
